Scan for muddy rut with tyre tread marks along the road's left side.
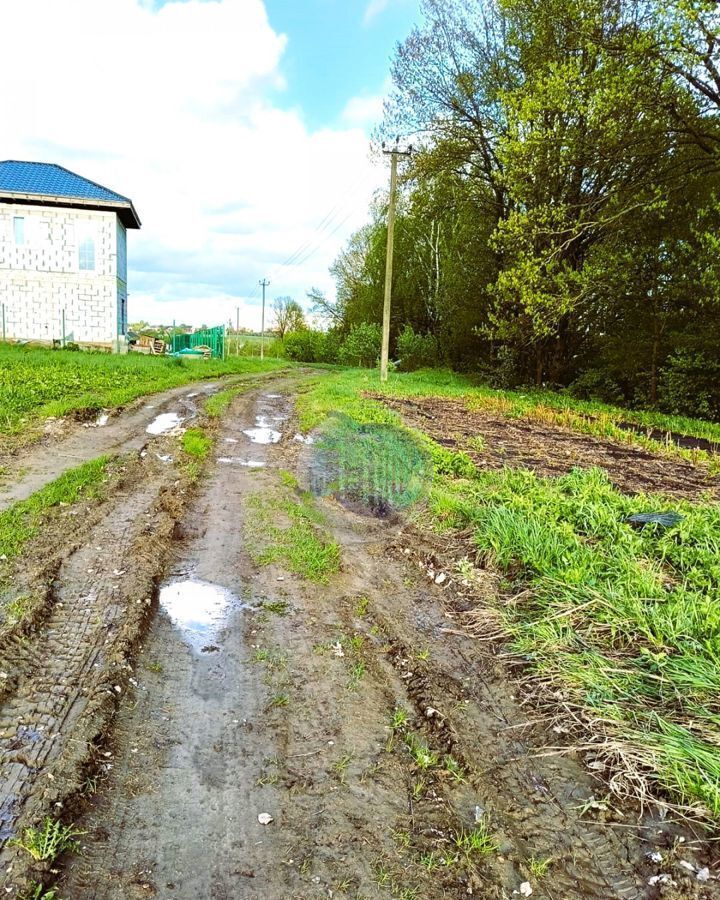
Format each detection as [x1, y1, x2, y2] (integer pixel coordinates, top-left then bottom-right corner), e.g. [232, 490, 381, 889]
[0, 450, 191, 892]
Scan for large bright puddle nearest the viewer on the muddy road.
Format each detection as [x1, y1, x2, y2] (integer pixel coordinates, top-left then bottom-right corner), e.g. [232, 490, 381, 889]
[160, 580, 246, 651]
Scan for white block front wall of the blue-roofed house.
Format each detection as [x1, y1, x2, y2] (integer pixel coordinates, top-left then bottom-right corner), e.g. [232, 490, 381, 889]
[0, 203, 118, 347]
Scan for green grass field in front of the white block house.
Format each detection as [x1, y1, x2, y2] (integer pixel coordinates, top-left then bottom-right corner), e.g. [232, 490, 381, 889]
[0, 344, 289, 434]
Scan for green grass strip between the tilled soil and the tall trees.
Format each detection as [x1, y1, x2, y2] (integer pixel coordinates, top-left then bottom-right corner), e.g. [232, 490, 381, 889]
[301, 369, 720, 472]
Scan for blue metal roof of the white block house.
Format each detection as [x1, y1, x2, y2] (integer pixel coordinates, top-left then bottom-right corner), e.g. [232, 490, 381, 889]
[0, 159, 140, 228]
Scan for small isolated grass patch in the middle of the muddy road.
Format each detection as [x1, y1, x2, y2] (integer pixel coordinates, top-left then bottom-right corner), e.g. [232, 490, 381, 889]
[245, 484, 340, 584]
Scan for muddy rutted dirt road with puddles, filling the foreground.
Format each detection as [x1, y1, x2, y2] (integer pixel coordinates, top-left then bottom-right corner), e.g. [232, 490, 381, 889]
[0, 378, 713, 900]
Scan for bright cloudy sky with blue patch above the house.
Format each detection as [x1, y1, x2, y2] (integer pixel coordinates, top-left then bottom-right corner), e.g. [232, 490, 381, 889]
[0, 0, 418, 328]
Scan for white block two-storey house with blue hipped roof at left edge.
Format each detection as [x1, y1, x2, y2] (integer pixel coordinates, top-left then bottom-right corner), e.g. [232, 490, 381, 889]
[0, 160, 140, 349]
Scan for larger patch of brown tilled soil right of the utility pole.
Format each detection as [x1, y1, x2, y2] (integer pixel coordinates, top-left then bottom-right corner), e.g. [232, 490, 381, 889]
[377, 395, 720, 499]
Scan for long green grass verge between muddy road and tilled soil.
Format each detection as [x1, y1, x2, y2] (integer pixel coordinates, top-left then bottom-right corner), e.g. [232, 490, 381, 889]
[298, 371, 720, 821]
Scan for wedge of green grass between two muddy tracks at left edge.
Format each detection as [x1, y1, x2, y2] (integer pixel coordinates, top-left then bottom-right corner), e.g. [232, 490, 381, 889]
[0, 456, 110, 560]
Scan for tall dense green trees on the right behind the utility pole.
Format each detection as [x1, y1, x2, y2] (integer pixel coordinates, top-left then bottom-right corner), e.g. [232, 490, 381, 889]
[314, 0, 720, 418]
